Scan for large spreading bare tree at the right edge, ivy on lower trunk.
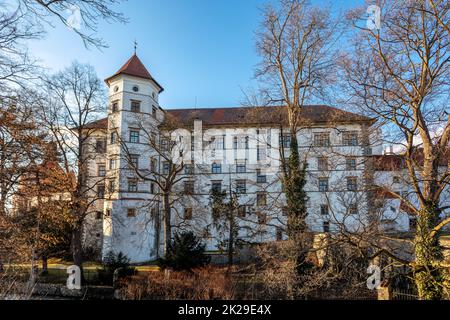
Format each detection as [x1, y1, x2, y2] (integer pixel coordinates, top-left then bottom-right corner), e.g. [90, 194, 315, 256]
[342, 0, 450, 299]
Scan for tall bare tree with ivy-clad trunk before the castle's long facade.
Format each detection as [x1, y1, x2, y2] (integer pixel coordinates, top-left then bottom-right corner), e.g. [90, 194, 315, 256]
[256, 0, 336, 237]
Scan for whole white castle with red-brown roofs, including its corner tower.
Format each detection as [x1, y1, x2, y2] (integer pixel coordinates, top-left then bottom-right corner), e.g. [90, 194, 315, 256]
[84, 55, 446, 262]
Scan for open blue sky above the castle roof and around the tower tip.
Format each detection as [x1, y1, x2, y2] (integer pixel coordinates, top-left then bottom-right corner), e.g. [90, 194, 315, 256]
[29, 0, 361, 108]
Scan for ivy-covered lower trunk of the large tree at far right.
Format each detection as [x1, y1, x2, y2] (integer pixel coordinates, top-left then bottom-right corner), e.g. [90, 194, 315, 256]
[414, 206, 444, 300]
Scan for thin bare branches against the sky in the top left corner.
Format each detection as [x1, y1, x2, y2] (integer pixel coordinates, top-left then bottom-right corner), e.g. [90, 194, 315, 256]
[0, 0, 127, 90]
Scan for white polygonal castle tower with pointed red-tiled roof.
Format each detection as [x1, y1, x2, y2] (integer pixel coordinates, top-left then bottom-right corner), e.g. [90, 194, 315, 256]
[102, 54, 164, 262]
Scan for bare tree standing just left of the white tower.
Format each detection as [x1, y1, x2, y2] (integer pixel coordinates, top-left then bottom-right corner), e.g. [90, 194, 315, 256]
[39, 62, 105, 280]
